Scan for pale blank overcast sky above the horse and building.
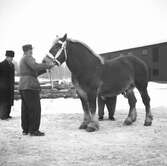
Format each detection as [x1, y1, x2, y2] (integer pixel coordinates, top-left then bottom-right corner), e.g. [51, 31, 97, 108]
[0, 0, 167, 61]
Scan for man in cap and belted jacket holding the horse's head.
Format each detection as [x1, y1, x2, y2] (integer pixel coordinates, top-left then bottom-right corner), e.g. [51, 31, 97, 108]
[19, 44, 54, 136]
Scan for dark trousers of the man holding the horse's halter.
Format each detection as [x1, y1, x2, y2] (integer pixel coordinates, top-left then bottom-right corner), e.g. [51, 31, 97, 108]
[20, 90, 41, 133]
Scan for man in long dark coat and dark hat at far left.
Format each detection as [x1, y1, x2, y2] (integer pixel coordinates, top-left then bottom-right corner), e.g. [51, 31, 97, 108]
[0, 50, 15, 120]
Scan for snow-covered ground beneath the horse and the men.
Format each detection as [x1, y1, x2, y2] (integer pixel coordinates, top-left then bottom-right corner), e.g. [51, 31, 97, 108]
[0, 83, 167, 166]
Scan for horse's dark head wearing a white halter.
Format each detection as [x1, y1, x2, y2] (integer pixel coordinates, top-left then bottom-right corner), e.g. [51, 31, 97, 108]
[49, 34, 67, 65]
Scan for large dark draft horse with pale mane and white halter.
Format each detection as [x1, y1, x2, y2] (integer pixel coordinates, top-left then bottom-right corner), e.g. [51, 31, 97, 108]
[49, 34, 153, 132]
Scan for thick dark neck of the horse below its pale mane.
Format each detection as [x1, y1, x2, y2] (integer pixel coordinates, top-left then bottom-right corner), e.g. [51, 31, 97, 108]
[67, 41, 102, 77]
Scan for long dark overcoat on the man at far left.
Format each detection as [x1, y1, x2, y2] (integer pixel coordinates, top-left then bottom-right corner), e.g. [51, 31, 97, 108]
[0, 60, 15, 105]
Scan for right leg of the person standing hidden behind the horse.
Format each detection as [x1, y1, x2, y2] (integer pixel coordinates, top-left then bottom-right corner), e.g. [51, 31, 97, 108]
[105, 96, 117, 120]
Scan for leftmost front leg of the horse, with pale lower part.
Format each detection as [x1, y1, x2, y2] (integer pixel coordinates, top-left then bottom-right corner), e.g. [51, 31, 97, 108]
[79, 97, 91, 129]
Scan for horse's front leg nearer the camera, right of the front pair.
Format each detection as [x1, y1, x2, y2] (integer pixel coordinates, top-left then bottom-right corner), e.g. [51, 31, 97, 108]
[86, 94, 99, 132]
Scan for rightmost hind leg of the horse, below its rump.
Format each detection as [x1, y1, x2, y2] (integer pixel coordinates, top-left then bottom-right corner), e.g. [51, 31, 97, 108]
[140, 87, 153, 126]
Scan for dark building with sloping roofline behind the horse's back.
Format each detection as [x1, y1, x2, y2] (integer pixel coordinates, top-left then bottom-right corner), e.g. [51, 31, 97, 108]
[100, 42, 167, 82]
